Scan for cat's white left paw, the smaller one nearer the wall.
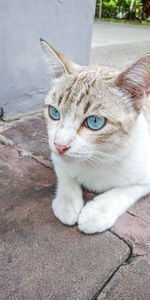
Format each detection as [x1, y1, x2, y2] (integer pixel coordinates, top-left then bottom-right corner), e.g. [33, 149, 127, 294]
[52, 198, 83, 226]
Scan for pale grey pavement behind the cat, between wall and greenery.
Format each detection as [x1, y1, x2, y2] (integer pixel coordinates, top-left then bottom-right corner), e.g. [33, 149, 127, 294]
[91, 22, 150, 69]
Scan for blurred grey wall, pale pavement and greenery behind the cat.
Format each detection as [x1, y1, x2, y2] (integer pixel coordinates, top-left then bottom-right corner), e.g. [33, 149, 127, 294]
[0, 0, 150, 120]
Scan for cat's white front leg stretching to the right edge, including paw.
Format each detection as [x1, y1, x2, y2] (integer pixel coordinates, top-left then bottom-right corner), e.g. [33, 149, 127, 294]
[78, 184, 150, 234]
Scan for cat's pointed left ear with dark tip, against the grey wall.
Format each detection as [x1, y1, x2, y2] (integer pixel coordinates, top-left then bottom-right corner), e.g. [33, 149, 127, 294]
[40, 39, 81, 78]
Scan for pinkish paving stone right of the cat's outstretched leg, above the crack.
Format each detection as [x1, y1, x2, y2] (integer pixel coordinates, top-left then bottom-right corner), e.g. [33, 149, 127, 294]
[112, 196, 150, 255]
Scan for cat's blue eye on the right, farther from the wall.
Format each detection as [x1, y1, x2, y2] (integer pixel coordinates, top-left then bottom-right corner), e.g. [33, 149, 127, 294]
[84, 116, 106, 130]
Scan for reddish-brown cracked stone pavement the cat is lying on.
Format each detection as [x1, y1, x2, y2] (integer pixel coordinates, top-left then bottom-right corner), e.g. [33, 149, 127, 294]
[0, 114, 150, 300]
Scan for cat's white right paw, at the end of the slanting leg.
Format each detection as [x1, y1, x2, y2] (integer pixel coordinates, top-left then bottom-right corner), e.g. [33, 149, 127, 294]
[78, 201, 116, 234]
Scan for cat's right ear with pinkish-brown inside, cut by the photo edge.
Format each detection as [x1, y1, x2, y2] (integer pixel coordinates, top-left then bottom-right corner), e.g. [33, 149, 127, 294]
[116, 53, 150, 109]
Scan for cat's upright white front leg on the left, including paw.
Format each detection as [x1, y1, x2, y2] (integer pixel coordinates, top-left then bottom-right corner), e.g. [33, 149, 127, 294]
[52, 168, 83, 225]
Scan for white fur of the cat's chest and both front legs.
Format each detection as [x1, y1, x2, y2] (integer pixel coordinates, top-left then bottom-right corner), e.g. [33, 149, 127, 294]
[52, 114, 150, 233]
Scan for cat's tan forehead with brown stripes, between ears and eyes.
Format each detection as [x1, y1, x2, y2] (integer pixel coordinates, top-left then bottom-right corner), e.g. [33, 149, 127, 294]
[46, 68, 129, 116]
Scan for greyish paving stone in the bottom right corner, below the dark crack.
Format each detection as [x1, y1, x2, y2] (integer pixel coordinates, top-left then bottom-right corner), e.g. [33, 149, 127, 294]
[97, 255, 150, 300]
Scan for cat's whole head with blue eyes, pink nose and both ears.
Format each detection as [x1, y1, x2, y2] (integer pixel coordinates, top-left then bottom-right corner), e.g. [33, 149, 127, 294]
[41, 40, 150, 164]
